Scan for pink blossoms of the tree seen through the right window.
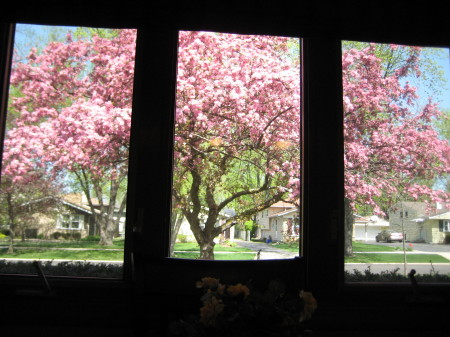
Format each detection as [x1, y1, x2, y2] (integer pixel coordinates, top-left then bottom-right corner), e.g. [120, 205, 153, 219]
[342, 45, 450, 254]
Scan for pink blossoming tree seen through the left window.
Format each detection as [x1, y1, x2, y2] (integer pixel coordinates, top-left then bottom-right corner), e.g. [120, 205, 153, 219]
[2, 30, 136, 245]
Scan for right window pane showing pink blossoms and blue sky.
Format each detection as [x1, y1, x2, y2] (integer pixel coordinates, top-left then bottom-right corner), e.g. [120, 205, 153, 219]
[342, 41, 450, 282]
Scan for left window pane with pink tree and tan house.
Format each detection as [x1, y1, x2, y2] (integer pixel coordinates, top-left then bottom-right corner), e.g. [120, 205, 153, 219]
[0, 24, 136, 277]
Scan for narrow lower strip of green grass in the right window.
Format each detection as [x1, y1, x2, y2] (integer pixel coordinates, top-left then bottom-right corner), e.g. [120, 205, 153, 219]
[345, 253, 450, 263]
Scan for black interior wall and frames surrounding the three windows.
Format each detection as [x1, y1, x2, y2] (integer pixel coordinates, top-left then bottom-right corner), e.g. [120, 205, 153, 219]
[0, 0, 450, 336]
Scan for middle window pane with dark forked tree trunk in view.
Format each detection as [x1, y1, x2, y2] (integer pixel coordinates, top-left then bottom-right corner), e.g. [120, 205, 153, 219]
[171, 31, 300, 260]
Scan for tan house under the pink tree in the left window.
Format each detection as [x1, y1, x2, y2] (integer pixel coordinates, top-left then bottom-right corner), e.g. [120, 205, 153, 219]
[19, 193, 125, 239]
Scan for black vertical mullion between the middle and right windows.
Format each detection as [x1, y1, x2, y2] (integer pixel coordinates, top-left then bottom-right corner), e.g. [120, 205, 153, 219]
[303, 38, 344, 292]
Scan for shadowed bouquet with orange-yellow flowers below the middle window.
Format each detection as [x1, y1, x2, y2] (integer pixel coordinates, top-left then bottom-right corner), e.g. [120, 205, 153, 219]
[169, 277, 317, 337]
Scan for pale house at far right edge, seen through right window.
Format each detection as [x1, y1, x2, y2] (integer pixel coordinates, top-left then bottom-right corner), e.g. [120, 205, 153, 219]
[389, 201, 450, 243]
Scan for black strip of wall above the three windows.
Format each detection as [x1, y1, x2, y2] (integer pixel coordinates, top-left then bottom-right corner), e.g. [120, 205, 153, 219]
[1, 0, 448, 44]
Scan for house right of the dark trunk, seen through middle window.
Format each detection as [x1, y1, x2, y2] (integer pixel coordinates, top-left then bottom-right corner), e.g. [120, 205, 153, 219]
[255, 201, 300, 241]
